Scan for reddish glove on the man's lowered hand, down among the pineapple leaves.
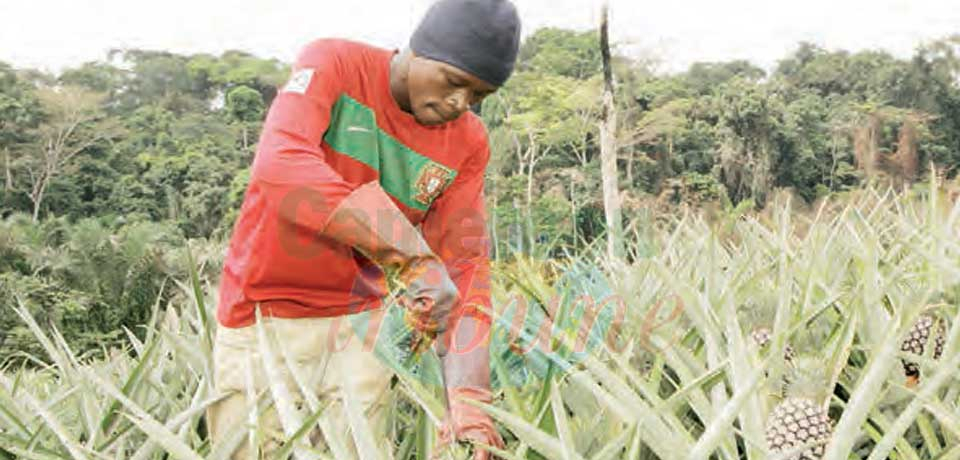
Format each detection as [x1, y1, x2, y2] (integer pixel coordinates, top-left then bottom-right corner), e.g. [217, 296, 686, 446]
[434, 387, 506, 460]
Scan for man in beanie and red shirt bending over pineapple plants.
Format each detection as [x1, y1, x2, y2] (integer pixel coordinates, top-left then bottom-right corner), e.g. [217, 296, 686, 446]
[208, 0, 520, 459]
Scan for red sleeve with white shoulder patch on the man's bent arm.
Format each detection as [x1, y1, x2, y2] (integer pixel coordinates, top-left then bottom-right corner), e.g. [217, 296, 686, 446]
[251, 40, 356, 233]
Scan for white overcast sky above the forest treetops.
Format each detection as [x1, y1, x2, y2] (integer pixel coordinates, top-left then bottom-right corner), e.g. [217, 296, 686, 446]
[0, 0, 960, 75]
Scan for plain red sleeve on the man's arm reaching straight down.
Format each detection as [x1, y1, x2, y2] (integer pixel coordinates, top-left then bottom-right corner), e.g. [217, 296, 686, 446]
[421, 131, 491, 337]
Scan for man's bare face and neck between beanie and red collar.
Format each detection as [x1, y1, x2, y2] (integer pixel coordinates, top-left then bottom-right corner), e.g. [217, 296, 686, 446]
[390, 49, 497, 126]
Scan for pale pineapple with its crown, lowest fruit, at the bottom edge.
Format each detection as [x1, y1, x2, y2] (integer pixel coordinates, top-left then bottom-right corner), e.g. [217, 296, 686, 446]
[766, 357, 833, 460]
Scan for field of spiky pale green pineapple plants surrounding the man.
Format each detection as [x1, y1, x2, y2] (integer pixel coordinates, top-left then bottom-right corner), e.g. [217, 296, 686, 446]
[0, 181, 960, 460]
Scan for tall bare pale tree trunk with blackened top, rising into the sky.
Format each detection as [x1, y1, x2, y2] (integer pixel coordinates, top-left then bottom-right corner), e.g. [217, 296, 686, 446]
[600, 1, 623, 258]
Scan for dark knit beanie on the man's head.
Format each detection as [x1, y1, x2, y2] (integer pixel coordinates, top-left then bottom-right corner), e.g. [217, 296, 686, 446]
[410, 0, 520, 86]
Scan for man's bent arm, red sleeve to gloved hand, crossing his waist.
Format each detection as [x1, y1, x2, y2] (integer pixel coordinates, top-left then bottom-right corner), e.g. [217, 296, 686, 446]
[251, 40, 457, 312]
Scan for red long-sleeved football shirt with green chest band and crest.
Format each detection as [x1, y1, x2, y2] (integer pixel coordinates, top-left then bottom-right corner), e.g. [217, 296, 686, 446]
[217, 39, 490, 327]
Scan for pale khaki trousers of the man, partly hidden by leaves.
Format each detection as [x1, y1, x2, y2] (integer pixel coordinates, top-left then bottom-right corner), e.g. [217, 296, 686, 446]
[207, 311, 393, 459]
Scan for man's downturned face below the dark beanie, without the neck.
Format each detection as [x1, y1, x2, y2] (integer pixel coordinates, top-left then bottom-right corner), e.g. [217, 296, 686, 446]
[407, 56, 497, 126]
